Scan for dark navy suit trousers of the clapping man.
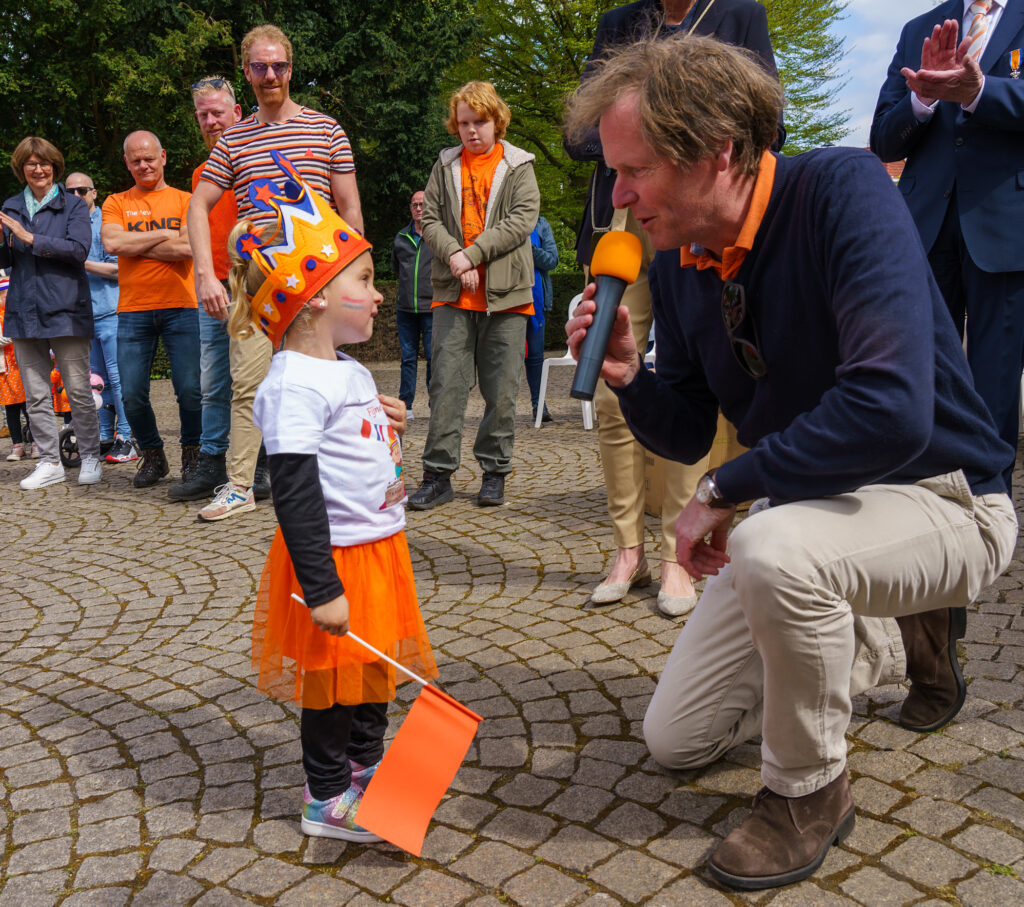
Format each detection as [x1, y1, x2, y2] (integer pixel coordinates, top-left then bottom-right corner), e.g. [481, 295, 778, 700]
[928, 195, 1024, 487]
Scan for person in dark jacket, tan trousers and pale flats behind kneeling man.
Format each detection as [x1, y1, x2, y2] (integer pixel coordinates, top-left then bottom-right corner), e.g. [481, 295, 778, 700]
[565, 0, 785, 616]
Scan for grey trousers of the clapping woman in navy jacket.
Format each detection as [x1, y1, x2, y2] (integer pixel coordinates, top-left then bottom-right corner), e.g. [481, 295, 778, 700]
[14, 337, 99, 463]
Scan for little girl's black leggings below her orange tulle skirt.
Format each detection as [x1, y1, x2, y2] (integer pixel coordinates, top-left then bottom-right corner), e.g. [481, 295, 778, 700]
[299, 702, 387, 800]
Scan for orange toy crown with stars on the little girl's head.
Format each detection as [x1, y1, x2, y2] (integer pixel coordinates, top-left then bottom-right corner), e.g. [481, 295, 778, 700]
[236, 150, 373, 349]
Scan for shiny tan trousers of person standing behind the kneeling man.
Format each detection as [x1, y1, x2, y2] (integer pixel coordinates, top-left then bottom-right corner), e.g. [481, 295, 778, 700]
[585, 211, 708, 562]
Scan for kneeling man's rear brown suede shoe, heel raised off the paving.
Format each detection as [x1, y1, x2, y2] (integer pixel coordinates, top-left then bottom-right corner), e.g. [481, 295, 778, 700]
[896, 608, 967, 732]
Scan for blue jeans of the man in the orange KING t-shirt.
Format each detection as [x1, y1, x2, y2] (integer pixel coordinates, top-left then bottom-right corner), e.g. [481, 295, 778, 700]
[118, 308, 203, 450]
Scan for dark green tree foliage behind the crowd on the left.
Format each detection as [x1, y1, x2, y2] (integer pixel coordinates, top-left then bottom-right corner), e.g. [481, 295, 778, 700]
[0, 0, 475, 264]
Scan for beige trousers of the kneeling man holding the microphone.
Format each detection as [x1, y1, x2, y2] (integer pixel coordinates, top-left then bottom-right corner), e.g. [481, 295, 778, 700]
[644, 472, 1017, 796]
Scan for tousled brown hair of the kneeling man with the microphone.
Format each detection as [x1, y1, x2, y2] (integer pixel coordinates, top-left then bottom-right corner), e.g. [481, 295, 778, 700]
[564, 35, 783, 176]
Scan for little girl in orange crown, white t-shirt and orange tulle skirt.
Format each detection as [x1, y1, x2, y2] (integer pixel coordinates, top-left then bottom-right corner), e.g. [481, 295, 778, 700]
[228, 152, 437, 841]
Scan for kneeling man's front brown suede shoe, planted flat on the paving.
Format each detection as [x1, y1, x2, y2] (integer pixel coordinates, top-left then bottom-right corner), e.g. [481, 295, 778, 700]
[708, 771, 854, 891]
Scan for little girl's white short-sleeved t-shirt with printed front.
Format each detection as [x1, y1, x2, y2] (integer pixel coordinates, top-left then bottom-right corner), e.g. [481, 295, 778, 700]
[253, 350, 406, 547]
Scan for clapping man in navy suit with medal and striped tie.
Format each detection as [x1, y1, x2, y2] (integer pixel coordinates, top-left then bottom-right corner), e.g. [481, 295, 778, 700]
[871, 0, 1024, 485]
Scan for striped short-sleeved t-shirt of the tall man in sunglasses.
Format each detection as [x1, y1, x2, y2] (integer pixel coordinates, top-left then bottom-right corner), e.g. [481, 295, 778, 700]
[202, 107, 355, 222]
